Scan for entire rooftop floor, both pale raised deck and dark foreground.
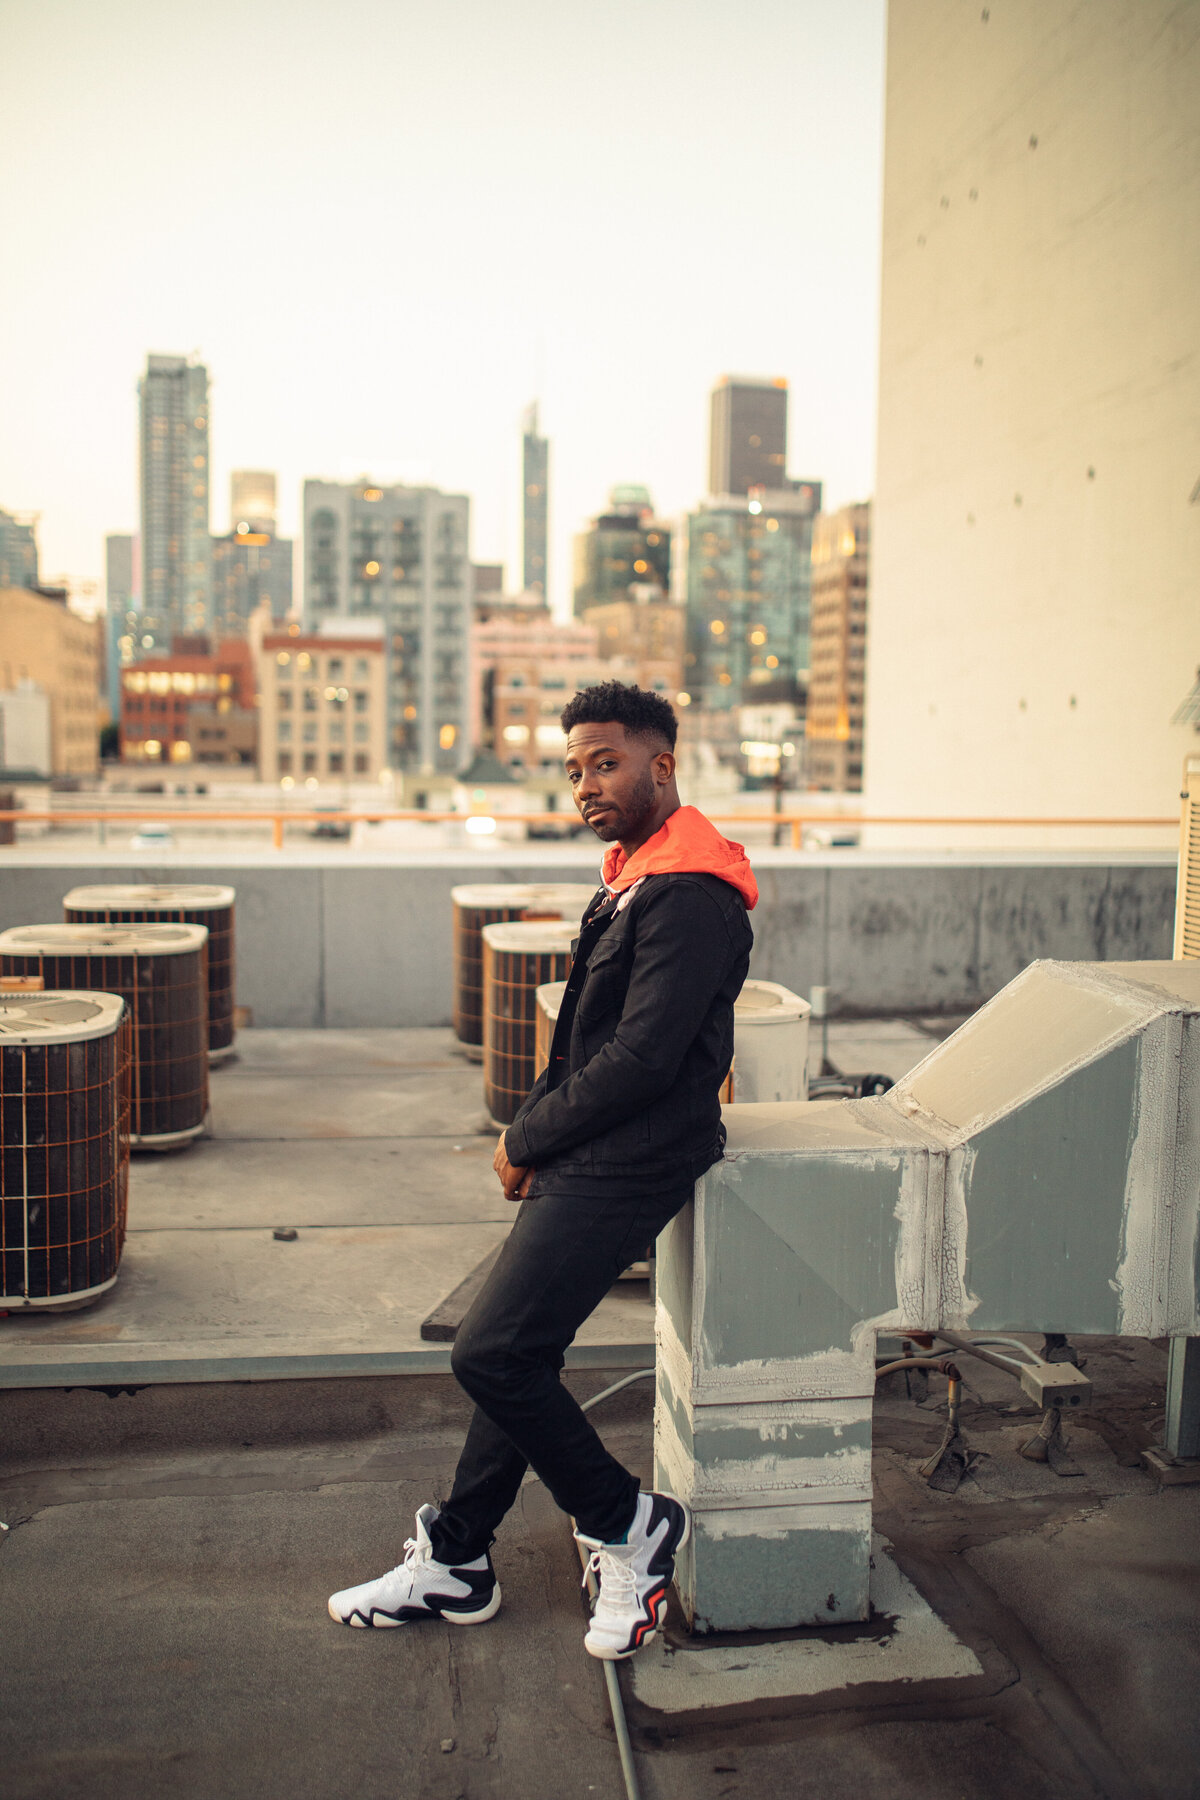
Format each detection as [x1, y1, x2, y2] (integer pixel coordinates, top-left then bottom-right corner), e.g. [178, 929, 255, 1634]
[0, 1021, 1200, 1800]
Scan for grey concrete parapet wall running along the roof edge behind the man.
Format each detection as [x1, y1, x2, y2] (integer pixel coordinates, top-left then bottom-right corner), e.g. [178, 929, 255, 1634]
[0, 848, 1175, 1028]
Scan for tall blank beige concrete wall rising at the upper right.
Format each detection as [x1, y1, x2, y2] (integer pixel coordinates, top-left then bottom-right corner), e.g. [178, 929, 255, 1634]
[865, 0, 1200, 842]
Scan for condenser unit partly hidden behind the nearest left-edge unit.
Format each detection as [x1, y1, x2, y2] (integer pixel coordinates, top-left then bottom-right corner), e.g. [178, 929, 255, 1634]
[0, 925, 209, 1150]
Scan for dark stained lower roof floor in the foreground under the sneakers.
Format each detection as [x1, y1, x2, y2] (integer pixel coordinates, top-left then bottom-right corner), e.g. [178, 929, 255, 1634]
[0, 1339, 1200, 1800]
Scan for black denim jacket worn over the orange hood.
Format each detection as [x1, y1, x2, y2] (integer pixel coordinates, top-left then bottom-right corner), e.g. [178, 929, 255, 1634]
[506, 873, 754, 1190]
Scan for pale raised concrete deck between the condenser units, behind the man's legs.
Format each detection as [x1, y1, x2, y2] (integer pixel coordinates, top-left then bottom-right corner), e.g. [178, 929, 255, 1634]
[0, 1030, 653, 1388]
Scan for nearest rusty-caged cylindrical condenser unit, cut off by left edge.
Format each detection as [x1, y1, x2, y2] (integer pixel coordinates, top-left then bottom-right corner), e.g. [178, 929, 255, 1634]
[0, 992, 130, 1312]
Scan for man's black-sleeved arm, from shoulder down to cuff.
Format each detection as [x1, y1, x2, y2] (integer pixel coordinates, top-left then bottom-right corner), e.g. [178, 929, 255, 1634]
[506, 882, 734, 1166]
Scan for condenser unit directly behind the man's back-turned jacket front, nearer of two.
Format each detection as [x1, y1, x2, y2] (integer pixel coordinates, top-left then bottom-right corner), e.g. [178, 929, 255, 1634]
[484, 920, 579, 1125]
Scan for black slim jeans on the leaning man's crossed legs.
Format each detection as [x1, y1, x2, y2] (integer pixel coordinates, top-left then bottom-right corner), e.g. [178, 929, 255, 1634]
[430, 1184, 693, 1564]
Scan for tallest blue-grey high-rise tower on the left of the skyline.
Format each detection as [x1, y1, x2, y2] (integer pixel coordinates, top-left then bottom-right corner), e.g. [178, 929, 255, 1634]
[139, 356, 212, 637]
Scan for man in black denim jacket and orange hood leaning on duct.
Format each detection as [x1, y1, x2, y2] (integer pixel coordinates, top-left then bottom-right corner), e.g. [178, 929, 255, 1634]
[329, 682, 757, 1660]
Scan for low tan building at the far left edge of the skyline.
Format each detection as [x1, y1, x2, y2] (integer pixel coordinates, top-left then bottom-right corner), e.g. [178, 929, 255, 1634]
[0, 587, 103, 776]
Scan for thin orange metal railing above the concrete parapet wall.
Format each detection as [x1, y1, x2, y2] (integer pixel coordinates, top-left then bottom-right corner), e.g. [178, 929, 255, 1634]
[0, 806, 1178, 850]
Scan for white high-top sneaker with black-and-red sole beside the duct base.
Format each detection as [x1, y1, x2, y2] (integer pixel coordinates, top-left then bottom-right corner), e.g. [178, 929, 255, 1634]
[576, 1494, 691, 1663]
